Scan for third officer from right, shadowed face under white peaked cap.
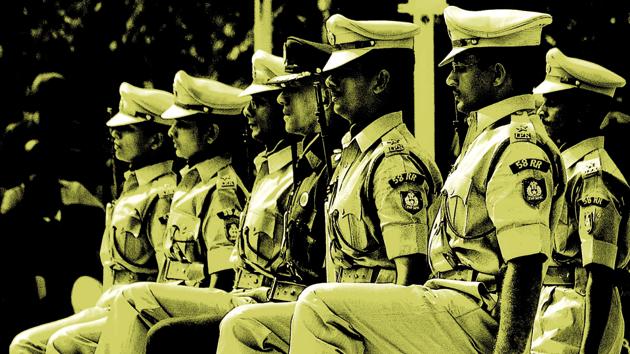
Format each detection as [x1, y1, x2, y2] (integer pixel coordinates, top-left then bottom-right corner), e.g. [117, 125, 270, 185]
[219, 15, 442, 353]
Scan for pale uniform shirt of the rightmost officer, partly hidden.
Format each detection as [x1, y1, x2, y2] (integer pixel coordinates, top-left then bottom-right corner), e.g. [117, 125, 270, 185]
[552, 136, 630, 270]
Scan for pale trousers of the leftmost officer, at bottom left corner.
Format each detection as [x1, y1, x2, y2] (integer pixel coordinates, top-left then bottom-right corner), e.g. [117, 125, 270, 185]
[9, 306, 109, 354]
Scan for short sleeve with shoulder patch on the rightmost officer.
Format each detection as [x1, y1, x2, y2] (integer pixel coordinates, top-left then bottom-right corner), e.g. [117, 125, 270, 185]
[576, 174, 621, 269]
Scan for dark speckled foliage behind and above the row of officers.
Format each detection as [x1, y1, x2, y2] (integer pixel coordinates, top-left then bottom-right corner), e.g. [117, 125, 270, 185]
[0, 0, 630, 191]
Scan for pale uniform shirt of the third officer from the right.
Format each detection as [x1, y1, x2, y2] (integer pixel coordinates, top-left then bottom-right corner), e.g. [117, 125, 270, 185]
[326, 112, 442, 281]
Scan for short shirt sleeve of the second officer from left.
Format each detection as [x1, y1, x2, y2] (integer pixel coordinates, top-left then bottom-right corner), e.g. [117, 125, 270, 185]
[203, 188, 242, 274]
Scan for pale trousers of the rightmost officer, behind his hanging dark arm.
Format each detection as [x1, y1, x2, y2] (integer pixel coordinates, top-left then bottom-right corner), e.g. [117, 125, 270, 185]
[532, 286, 624, 354]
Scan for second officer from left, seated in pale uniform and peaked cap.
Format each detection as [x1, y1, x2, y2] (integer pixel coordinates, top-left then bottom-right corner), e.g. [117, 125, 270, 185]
[97, 71, 249, 353]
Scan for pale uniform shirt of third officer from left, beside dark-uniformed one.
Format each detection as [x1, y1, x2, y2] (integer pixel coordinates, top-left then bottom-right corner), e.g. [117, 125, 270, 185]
[237, 141, 293, 275]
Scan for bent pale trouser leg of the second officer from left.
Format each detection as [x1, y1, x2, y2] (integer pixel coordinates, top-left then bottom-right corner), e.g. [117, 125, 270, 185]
[96, 283, 238, 354]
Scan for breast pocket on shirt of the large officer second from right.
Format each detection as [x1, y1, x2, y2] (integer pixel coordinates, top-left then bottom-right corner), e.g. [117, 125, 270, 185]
[444, 176, 472, 238]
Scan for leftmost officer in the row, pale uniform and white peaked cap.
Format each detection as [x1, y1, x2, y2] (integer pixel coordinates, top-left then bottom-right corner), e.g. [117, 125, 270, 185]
[9, 83, 176, 353]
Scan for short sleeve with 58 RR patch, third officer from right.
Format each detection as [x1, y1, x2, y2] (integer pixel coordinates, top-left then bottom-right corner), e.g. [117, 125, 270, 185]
[373, 154, 430, 259]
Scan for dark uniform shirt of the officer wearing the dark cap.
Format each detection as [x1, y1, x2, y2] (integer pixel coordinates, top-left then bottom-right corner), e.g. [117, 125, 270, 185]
[279, 134, 328, 285]
